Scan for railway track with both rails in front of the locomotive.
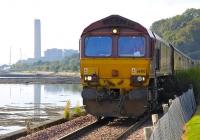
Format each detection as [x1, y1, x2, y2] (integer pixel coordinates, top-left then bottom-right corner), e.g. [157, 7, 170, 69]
[59, 116, 149, 140]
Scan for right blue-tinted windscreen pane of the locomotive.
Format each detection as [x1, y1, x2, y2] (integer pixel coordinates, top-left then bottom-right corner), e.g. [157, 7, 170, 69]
[118, 36, 145, 57]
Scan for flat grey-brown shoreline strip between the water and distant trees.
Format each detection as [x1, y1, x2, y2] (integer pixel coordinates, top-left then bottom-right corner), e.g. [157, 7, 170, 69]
[0, 73, 80, 84]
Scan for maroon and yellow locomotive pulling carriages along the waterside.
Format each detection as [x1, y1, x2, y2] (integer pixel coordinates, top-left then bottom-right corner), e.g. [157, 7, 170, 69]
[79, 15, 195, 118]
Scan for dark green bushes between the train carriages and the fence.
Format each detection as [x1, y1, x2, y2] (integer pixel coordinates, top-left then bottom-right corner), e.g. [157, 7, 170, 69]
[175, 66, 200, 102]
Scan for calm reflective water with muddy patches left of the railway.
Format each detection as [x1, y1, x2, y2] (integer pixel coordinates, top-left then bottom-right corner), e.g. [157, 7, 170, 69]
[0, 84, 82, 135]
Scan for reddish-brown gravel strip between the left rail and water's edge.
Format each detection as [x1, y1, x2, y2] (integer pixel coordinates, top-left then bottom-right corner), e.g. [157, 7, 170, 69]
[18, 115, 96, 140]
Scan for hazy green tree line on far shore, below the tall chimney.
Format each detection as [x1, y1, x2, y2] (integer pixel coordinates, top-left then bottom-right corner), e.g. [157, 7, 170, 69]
[11, 54, 79, 72]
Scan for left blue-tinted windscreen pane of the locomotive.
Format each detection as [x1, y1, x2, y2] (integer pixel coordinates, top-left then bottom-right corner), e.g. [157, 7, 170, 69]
[85, 36, 112, 57]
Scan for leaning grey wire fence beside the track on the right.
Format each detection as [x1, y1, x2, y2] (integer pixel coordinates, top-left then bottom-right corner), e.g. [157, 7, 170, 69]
[150, 89, 196, 140]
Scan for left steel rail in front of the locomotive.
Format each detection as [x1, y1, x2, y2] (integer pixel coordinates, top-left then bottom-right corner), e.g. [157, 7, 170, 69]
[58, 118, 110, 140]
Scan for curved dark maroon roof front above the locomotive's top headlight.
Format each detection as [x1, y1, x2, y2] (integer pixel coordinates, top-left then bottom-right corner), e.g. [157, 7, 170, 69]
[82, 15, 151, 36]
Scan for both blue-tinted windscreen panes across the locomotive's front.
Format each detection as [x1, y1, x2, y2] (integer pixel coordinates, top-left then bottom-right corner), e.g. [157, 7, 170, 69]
[84, 36, 146, 57]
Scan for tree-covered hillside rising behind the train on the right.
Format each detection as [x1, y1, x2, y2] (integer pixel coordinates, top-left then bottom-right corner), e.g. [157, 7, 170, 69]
[151, 9, 200, 59]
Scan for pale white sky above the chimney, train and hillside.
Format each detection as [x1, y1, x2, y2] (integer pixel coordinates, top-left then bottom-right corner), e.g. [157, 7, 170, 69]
[0, 0, 200, 64]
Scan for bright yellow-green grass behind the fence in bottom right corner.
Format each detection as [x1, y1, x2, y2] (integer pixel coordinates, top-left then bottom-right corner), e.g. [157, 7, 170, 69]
[183, 106, 200, 140]
